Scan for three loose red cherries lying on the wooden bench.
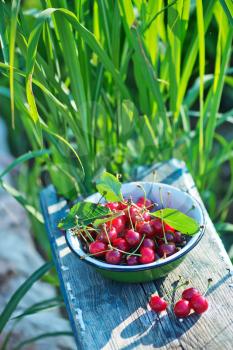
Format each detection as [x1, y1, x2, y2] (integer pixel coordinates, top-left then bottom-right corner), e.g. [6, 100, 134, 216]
[149, 287, 209, 318]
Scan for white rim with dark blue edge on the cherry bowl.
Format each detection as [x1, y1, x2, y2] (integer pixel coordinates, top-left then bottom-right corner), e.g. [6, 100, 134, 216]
[65, 185, 206, 273]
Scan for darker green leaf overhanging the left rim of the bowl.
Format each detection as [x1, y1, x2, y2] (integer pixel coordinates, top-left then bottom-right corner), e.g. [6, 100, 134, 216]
[58, 202, 110, 230]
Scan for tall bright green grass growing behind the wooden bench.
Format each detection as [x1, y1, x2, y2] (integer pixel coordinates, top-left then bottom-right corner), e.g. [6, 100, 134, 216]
[0, 0, 233, 348]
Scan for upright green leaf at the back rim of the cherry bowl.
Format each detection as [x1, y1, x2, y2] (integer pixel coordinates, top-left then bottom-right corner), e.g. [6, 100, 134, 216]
[96, 172, 122, 202]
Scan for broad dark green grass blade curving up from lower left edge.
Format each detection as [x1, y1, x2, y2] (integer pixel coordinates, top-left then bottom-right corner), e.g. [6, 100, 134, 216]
[0, 262, 53, 333]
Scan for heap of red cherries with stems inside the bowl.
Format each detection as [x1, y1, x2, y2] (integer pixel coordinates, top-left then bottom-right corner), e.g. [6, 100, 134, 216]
[79, 197, 186, 266]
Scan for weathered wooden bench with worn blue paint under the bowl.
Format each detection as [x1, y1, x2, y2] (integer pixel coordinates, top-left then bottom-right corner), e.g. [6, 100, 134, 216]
[41, 159, 233, 350]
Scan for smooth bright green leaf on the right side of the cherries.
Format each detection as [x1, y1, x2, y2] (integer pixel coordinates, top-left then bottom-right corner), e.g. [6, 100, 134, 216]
[151, 208, 199, 236]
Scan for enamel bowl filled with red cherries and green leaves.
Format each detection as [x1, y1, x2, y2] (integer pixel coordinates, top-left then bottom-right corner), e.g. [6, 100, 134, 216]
[58, 173, 205, 282]
